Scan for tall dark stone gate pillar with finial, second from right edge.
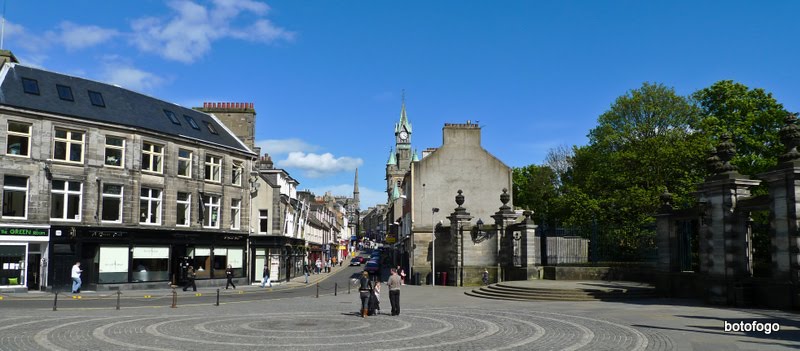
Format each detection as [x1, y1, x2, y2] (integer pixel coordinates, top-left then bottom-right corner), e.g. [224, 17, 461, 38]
[698, 135, 760, 304]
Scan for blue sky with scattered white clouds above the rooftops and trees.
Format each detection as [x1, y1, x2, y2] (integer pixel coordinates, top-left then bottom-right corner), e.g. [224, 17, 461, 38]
[3, 0, 800, 208]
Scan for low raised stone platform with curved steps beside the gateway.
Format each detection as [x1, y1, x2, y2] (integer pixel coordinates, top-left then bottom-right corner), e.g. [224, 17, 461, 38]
[465, 280, 658, 301]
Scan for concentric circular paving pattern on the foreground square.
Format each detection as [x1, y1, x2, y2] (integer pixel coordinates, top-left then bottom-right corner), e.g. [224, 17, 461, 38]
[0, 307, 673, 350]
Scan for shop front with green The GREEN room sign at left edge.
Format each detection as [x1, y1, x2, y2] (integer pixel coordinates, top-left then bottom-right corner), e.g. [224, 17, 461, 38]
[0, 224, 50, 291]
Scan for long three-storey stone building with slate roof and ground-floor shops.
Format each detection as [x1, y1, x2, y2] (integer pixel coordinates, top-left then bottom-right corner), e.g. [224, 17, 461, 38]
[0, 51, 256, 289]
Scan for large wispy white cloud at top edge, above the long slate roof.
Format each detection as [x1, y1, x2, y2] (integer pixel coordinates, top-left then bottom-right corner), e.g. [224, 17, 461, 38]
[131, 0, 295, 63]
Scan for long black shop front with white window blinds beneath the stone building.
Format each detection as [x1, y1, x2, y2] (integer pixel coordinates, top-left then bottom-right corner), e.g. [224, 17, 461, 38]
[48, 227, 247, 290]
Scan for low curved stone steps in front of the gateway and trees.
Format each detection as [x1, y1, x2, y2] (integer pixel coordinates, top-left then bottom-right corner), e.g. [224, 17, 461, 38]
[465, 283, 658, 301]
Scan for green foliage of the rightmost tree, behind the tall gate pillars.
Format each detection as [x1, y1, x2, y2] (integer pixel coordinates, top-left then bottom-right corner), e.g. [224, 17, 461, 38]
[692, 80, 788, 176]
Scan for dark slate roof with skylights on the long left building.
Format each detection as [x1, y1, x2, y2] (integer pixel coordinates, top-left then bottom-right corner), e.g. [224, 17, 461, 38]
[0, 63, 252, 153]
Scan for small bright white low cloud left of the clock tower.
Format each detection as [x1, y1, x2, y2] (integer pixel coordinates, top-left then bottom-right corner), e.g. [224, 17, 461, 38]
[277, 151, 364, 178]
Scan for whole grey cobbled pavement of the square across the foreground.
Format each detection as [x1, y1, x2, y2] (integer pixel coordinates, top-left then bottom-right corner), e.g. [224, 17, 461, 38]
[0, 286, 800, 350]
